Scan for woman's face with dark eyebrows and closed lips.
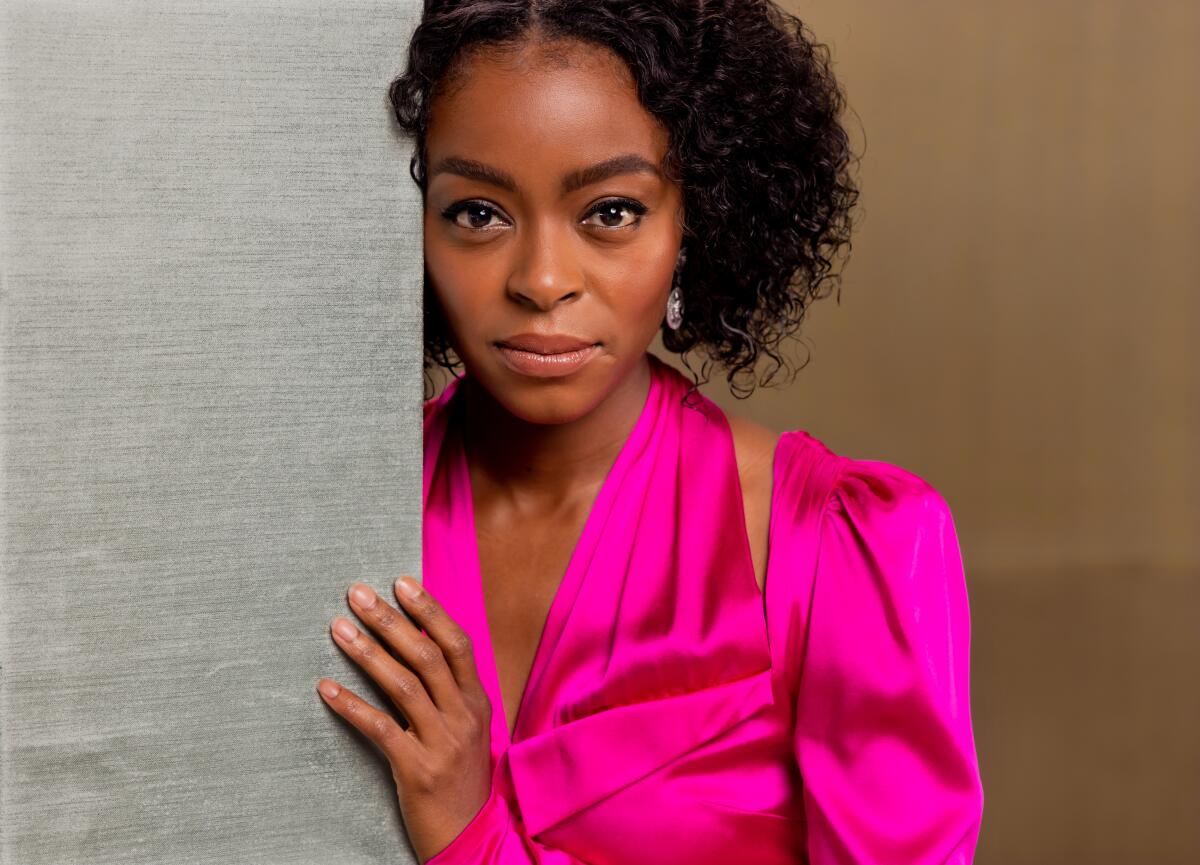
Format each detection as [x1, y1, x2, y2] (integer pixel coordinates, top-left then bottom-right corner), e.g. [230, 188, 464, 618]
[425, 42, 683, 424]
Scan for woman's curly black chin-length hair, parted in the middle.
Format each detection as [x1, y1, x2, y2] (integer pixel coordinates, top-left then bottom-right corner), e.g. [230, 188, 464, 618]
[388, 0, 858, 397]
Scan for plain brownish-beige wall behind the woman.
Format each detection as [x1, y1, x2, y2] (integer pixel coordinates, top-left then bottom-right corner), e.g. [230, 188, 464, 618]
[660, 0, 1200, 865]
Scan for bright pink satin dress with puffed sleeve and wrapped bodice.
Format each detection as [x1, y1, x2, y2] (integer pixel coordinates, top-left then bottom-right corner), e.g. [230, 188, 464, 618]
[422, 355, 983, 865]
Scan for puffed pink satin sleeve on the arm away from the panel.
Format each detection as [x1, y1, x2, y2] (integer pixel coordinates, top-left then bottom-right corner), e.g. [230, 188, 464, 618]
[793, 458, 983, 865]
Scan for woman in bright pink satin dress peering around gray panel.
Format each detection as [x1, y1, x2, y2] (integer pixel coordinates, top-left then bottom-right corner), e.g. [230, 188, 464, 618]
[320, 0, 983, 865]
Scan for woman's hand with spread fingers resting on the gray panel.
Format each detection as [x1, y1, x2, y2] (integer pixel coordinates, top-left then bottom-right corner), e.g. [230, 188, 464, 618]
[318, 577, 492, 863]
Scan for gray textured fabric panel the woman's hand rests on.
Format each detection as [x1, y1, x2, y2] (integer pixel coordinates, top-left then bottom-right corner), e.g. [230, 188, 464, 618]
[0, 0, 422, 865]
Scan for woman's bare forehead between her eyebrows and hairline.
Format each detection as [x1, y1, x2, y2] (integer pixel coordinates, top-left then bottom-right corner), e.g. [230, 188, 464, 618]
[426, 42, 668, 184]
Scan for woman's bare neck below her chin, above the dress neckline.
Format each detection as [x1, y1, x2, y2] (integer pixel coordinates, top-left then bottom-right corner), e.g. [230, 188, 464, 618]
[462, 354, 652, 506]
